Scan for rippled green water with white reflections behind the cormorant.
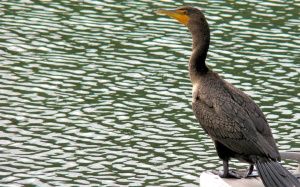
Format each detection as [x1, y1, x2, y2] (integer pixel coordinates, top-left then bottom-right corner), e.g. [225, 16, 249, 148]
[0, 0, 300, 186]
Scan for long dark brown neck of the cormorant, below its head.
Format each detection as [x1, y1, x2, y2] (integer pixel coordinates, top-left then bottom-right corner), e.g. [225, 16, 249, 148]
[189, 21, 210, 82]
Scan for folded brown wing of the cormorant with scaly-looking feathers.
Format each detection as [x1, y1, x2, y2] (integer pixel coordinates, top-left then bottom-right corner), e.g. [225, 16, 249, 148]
[193, 74, 278, 159]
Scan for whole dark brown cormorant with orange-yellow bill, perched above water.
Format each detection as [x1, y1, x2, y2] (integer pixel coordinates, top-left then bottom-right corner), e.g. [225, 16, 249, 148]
[158, 7, 300, 187]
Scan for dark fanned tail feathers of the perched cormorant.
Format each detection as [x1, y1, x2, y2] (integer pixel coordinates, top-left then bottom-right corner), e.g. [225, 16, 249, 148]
[255, 160, 300, 187]
